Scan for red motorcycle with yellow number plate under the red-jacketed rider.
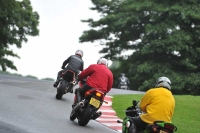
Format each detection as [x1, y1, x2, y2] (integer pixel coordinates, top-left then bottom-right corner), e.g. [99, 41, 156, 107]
[70, 81, 107, 126]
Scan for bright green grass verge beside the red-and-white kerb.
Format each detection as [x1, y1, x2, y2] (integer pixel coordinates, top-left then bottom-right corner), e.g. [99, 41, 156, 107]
[112, 94, 200, 133]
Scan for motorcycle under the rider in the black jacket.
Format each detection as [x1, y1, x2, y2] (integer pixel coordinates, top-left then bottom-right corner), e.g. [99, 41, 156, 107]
[56, 70, 77, 99]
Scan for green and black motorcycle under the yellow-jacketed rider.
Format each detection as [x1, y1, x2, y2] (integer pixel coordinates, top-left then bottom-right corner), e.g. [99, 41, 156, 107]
[117, 100, 177, 133]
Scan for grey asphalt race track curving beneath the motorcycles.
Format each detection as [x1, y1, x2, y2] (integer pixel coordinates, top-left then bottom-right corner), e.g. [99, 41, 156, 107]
[0, 74, 142, 133]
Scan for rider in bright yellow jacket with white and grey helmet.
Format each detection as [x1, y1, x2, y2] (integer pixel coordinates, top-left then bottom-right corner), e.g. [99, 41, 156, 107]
[125, 77, 175, 133]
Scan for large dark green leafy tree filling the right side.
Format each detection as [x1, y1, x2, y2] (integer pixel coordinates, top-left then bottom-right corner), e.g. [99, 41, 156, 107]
[79, 0, 200, 94]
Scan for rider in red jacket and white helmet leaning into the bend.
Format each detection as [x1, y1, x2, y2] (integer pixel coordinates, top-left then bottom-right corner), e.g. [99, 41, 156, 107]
[74, 58, 113, 105]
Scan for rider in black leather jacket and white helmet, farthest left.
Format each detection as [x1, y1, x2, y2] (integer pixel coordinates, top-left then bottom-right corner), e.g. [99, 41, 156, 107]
[53, 50, 84, 93]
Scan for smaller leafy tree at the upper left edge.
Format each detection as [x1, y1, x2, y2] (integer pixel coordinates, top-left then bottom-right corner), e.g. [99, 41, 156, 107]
[0, 0, 39, 71]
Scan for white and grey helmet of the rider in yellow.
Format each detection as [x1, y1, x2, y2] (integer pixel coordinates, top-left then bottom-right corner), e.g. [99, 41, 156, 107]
[156, 77, 171, 90]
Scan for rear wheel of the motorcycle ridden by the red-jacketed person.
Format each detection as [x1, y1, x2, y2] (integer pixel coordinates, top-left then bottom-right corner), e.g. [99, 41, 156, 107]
[78, 106, 94, 126]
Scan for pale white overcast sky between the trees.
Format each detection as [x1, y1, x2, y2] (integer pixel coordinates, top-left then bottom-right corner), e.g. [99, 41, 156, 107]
[9, 0, 104, 79]
